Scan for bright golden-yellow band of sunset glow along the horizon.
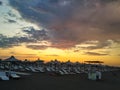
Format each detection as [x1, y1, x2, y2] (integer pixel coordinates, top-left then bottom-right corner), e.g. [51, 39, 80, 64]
[0, 46, 120, 66]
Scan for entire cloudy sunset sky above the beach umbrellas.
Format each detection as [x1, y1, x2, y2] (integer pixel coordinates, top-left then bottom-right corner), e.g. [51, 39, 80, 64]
[0, 0, 120, 66]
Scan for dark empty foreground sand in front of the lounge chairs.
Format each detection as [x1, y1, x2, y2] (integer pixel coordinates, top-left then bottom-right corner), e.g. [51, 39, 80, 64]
[0, 71, 120, 90]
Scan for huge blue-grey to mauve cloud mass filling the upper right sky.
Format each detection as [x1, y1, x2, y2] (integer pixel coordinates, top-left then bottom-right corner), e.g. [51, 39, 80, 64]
[9, 0, 120, 48]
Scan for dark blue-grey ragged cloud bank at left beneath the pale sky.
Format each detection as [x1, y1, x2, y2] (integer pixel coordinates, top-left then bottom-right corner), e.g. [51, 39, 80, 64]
[0, 27, 47, 49]
